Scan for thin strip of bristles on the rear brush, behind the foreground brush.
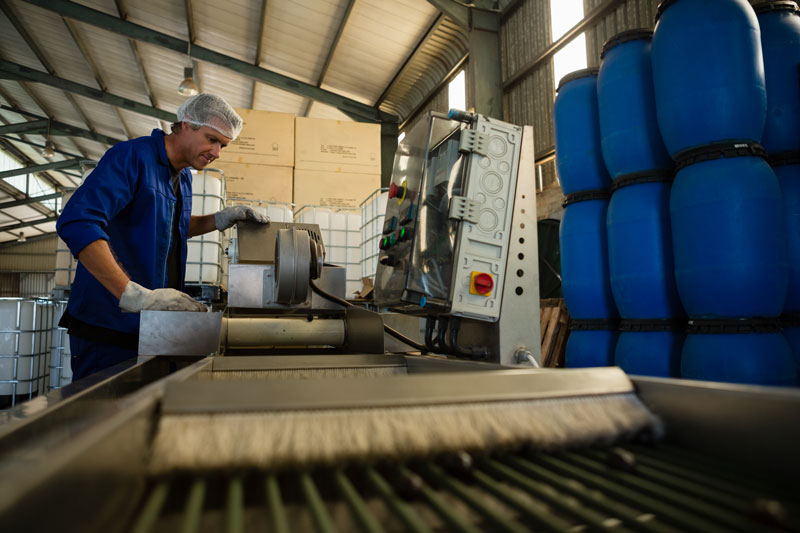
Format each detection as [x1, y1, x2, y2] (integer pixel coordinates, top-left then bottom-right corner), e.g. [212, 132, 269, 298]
[196, 365, 408, 381]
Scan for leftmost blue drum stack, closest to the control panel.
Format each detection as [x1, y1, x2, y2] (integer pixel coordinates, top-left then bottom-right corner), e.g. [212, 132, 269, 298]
[554, 69, 619, 367]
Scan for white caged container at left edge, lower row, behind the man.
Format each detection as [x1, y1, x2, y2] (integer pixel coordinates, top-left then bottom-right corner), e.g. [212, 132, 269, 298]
[0, 298, 54, 405]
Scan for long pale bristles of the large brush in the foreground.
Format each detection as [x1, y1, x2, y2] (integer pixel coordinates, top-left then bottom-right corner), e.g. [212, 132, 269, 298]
[150, 394, 661, 474]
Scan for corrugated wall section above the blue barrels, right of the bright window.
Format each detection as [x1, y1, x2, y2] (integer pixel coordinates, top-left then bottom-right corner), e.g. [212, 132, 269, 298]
[583, 0, 660, 67]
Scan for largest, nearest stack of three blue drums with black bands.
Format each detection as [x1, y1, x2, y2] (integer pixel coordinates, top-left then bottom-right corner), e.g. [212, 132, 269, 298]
[652, 0, 796, 385]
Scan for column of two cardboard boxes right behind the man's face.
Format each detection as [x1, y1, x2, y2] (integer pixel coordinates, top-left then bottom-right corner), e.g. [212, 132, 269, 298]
[212, 109, 294, 202]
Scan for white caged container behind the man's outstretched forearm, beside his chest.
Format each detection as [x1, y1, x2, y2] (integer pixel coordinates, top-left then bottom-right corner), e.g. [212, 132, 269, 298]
[185, 168, 225, 285]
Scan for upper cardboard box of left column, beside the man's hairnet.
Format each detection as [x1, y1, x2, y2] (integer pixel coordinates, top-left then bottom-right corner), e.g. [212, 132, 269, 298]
[215, 108, 294, 167]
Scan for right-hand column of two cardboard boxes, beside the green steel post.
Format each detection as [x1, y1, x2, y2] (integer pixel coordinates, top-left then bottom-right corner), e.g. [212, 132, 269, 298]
[293, 117, 381, 209]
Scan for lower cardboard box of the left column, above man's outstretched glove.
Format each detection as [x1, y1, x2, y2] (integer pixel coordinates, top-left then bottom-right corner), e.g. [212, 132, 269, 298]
[214, 159, 292, 202]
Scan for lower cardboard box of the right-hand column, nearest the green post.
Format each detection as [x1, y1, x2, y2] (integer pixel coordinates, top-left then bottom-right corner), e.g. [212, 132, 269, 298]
[292, 169, 381, 209]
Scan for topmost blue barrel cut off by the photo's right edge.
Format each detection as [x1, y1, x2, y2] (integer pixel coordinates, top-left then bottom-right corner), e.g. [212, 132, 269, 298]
[755, 0, 800, 154]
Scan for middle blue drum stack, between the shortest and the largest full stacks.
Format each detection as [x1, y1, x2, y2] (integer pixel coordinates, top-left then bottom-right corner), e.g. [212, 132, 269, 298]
[597, 30, 685, 377]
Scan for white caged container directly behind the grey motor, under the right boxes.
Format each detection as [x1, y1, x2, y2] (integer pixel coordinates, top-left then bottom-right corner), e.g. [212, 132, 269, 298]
[294, 205, 361, 298]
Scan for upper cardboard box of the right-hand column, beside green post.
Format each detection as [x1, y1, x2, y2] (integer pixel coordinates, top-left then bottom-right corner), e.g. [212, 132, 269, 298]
[294, 117, 381, 174]
